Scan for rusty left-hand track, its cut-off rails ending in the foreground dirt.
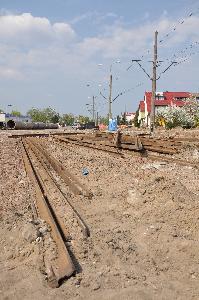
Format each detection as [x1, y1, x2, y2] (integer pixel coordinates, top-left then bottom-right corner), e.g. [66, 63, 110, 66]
[22, 138, 90, 287]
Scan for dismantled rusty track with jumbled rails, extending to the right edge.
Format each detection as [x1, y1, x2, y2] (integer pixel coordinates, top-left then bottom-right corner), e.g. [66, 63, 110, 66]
[53, 134, 199, 168]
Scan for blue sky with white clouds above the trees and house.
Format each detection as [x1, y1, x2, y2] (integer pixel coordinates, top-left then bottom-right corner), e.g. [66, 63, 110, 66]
[0, 0, 199, 116]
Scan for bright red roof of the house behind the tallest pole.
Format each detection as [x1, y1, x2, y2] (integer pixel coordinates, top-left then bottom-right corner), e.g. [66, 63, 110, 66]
[145, 92, 190, 112]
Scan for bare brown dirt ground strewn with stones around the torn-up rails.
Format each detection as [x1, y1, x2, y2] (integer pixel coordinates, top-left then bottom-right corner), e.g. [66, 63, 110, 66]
[0, 131, 199, 300]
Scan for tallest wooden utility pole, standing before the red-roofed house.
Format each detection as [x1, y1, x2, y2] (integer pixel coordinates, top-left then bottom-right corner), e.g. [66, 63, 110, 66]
[150, 31, 158, 132]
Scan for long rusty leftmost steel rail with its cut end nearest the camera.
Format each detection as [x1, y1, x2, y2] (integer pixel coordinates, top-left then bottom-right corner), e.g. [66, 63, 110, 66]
[22, 141, 75, 287]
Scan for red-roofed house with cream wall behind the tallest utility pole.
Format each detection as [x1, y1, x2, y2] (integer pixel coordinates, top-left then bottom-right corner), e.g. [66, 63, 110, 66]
[138, 91, 192, 126]
